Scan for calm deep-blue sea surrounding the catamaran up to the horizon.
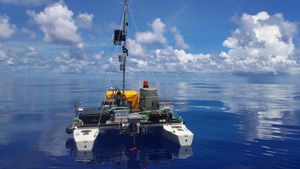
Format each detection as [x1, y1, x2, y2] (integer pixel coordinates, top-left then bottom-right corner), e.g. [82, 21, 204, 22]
[0, 74, 300, 169]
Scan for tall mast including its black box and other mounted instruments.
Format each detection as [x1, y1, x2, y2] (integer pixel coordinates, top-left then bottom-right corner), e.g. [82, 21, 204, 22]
[114, 0, 128, 102]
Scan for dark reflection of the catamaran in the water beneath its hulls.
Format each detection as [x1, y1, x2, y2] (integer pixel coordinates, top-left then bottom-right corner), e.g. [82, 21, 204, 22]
[66, 134, 193, 168]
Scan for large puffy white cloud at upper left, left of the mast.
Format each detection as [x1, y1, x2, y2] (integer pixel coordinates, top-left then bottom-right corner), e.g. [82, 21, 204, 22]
[27, 2, 83, 47]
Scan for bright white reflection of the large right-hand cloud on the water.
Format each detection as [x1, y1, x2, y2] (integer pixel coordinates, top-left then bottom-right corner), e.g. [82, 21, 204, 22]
[222, 84, 299, 140]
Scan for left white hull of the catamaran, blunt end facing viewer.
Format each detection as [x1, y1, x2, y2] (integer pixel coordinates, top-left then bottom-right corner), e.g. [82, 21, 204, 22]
[73, 127, 99, 151]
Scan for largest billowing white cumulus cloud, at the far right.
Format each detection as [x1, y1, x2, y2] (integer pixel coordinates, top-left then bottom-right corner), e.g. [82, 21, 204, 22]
[220, 11, 297, 73]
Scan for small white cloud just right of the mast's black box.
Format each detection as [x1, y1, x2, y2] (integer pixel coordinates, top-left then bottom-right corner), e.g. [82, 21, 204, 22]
[136, 18, 167, 45]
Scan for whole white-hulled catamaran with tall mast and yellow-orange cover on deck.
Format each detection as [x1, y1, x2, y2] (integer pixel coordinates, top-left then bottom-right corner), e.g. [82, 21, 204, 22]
[66, 0, 194, 151]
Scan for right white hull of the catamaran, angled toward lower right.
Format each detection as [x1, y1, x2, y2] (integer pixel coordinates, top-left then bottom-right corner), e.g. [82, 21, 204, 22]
[162, 123, 194, 146]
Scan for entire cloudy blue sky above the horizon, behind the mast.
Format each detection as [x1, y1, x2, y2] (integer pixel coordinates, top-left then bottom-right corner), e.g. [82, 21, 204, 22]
[0, 0, 300, 74]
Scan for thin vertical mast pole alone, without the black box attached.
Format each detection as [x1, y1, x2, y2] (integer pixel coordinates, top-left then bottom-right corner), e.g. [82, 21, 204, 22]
[122, 0, 128, 102]
